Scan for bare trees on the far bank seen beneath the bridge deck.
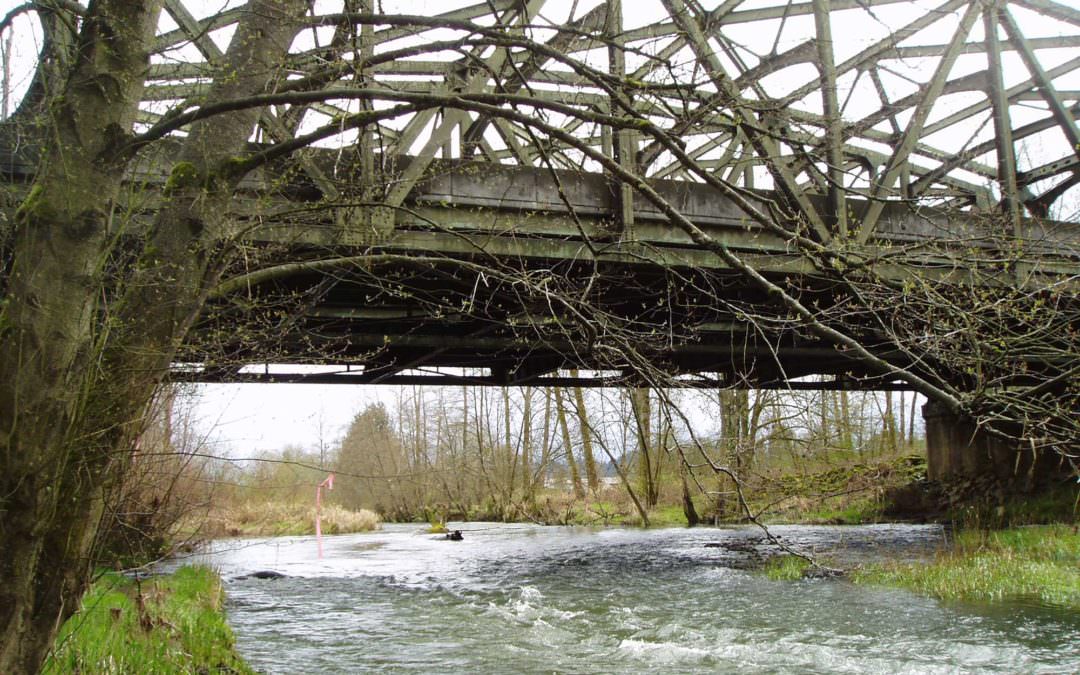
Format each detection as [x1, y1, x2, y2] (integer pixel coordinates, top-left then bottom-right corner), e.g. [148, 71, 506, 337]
[329, 387, 921, 523]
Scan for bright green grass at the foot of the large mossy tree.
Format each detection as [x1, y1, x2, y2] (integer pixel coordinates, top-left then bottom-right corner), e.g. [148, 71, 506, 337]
[43, 567, 254, 675]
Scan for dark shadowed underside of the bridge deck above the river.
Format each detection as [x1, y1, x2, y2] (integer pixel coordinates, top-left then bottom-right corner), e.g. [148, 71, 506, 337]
[183, 258, 894, 387]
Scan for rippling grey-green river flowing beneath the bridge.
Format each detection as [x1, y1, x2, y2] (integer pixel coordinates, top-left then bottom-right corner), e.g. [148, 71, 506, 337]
[187, 524, 1080, 674]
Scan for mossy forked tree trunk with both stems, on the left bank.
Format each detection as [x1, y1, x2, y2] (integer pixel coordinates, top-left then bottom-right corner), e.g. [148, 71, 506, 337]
[0, 0, 303, 674]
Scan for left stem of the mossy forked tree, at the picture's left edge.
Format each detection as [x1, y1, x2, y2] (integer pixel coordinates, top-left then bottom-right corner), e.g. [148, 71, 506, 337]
[0, 1, 158, 673]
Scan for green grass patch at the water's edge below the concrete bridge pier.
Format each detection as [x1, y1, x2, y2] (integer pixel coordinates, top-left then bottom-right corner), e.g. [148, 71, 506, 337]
[853, 525, 1080, 610]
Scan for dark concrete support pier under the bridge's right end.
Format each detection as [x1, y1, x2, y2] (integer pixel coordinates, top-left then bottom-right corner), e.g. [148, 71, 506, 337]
[922, 402, 1067, 487]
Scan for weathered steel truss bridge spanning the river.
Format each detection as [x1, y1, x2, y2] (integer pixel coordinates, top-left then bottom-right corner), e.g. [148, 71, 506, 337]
[0, 0, 1080, 388]
